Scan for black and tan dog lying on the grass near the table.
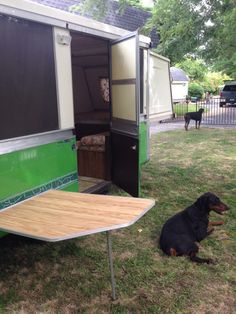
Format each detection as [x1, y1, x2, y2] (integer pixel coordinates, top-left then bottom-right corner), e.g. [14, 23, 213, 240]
[160, 192, 229, 264]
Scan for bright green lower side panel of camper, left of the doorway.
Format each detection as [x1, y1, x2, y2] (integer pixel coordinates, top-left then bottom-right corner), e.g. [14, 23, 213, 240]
[0, 137, 78, 236]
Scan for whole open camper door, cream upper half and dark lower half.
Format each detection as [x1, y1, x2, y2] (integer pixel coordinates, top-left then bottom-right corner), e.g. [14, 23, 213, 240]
[110, 33, 140, 196]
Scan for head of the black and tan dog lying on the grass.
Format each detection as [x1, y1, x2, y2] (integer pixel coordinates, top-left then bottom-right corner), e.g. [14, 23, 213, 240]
[196, 192, 229, 215]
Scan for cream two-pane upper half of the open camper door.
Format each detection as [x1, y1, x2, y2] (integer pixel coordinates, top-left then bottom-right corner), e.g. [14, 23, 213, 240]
[111, 33, 140, 136]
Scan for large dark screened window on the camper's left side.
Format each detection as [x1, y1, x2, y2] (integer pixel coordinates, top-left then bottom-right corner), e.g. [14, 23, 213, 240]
[0, 15, 58, 140]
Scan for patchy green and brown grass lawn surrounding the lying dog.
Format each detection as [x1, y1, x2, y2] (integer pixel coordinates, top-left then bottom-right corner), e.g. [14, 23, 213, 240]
[0, 127, 236, 314]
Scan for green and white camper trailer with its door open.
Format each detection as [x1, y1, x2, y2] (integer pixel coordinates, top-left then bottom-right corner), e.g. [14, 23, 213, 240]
[0, 0, 172, 228]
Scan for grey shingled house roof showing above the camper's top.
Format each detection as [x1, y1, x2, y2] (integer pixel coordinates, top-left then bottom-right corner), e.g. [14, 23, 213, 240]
[31, 0, 159, 48]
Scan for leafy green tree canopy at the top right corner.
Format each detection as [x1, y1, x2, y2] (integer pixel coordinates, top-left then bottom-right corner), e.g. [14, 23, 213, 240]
[147, 0, 236, 77]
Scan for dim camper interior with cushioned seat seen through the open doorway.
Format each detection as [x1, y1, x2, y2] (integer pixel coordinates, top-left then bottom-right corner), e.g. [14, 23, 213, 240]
[71, 32, 111, 193]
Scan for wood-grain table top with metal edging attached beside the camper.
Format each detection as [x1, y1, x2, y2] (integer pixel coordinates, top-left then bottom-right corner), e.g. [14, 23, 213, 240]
[0, 190, 155, 242]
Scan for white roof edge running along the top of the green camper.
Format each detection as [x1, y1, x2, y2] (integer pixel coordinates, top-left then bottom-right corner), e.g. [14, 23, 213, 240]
[0, 0, 133, 41]
